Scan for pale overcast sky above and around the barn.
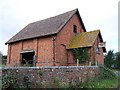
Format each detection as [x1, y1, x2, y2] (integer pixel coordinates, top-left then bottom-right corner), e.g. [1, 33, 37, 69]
[0, 0, 119, 55]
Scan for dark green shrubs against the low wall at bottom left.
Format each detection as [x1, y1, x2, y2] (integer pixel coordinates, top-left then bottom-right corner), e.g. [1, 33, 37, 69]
[2, 71, 31, 89]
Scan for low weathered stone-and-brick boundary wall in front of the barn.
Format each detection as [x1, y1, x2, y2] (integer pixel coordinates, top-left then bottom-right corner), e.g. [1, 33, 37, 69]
[1, 66, 99, 88]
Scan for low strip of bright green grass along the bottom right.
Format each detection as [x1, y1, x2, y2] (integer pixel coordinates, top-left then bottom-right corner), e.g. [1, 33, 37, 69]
[51, 78, 118, 90]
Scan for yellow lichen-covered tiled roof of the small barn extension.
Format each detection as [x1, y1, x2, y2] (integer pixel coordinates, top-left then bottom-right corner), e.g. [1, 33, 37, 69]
[67, 30, 100, 49]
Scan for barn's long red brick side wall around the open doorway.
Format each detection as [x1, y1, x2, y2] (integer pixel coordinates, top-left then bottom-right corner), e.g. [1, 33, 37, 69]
[7, 37, 53, 66]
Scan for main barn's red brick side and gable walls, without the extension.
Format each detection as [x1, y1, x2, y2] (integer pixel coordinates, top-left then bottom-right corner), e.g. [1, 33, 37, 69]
[8, 14, 86, 66]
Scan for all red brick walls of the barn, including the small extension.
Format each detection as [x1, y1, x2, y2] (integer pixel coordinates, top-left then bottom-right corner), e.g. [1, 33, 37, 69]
[7, 11, 104, 66]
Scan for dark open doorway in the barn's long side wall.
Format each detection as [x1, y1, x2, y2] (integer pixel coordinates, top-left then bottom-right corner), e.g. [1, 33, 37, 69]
[20, 51, 35, 67]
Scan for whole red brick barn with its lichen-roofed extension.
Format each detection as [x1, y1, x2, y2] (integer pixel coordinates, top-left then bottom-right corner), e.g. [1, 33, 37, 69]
[5, 9, 106, 66]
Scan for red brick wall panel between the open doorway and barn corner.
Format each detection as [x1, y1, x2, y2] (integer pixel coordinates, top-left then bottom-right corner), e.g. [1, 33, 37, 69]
[37, 37, 53, 66]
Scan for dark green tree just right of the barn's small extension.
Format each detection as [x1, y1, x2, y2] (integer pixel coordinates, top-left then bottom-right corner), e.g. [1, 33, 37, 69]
[104, 50, 115, 69]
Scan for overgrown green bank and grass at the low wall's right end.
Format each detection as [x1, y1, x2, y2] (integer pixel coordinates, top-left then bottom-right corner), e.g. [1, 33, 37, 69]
[53, 66, 120, 89]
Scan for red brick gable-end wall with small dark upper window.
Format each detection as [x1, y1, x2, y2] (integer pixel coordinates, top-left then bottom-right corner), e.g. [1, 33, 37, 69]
[55, 14, 83, 65]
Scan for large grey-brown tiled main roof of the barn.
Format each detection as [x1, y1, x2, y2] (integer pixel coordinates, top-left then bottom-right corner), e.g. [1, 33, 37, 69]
[6, 9, 85, 44]
